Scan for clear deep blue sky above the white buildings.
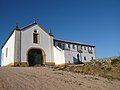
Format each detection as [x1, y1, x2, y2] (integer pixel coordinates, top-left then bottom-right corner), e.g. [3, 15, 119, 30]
[0, 0, 120, 58]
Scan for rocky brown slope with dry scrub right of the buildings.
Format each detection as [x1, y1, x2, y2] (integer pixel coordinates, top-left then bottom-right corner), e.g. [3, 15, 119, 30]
[62, 57, 120, 80]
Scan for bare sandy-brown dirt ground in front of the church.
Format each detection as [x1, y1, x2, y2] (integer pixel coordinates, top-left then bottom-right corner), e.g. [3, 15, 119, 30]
[0, 67, 120, 90]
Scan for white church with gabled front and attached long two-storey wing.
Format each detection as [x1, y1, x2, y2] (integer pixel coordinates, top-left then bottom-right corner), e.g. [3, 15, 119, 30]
[1, 22, 96, 66]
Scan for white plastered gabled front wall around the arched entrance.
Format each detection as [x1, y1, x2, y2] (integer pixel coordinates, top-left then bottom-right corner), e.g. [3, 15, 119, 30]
[21, 25, 52, 62]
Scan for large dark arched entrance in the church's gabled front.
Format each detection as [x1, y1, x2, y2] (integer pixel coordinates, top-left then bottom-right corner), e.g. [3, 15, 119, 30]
[28, 49, 45, 66]
